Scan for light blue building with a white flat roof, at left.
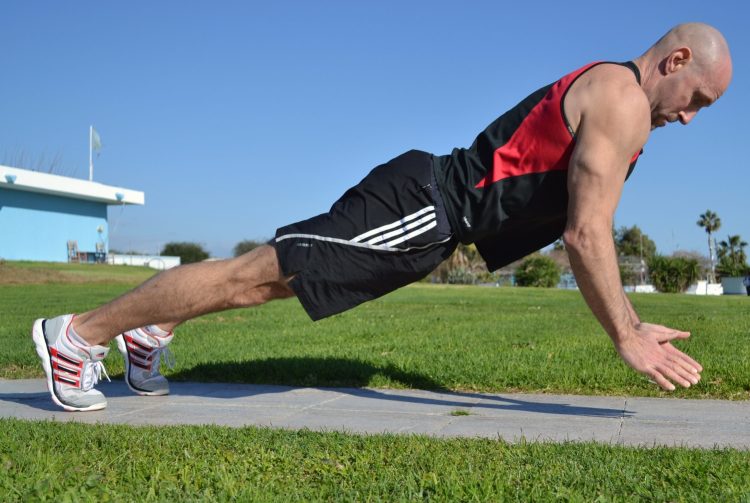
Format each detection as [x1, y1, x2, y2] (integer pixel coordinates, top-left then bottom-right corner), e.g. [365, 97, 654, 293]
[0, 165, 144, 262]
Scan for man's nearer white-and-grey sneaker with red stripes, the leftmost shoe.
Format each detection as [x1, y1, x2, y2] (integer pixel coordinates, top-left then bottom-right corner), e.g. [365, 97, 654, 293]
[31, 314, 109, 411]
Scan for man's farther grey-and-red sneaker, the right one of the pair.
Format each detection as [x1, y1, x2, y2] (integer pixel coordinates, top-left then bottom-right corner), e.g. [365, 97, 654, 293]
[115, 327, 174, 396]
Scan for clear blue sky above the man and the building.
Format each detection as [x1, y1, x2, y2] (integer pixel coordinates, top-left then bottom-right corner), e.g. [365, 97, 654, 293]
[0, 0, 750, 257]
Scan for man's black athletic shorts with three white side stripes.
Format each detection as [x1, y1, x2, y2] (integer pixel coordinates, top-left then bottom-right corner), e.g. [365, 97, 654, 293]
[270, 150, 458, 320]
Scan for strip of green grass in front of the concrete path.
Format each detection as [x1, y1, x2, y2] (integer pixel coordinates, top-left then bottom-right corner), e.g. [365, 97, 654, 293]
[0, 420, 750, 502]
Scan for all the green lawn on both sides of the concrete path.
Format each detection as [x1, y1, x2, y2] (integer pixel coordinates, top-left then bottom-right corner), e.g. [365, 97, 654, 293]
[0, 264, 750, 502]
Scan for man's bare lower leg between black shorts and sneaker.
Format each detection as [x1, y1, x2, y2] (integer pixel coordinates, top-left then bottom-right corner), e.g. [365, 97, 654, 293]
[73, 245, 294, 345]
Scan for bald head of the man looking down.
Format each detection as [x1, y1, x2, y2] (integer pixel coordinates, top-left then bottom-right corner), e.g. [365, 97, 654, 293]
[635, 23, 732, 127]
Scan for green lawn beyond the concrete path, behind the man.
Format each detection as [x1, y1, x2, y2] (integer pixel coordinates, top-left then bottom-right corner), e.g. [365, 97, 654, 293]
[0, 283, 750, 400]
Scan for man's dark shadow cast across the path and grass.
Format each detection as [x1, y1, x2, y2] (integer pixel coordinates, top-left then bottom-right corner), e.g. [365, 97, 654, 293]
[0, 357, 633, 418]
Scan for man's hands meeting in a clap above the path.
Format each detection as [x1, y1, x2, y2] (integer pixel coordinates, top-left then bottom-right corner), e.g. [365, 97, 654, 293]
[615, 323, 703, 391]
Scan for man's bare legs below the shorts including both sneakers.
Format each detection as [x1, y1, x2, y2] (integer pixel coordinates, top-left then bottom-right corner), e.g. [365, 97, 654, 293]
[32, 246, 294, 411]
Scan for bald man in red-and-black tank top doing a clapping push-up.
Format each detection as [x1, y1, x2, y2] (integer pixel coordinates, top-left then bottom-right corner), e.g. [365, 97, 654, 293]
[32, 23, 732, 410]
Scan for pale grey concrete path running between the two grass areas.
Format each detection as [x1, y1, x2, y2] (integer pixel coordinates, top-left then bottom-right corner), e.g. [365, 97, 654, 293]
[0, 379, 750, 450]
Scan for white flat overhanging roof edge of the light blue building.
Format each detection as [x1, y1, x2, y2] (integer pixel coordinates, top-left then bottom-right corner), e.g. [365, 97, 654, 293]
[0, 165, 145, 205]
